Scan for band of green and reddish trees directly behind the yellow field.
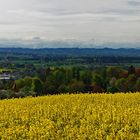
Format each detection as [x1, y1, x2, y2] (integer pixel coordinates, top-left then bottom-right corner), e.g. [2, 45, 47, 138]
[0, 66, 140, 99]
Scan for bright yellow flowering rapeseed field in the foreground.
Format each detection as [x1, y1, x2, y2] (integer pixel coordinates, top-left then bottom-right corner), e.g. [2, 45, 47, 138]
[0, 93, 140, 140]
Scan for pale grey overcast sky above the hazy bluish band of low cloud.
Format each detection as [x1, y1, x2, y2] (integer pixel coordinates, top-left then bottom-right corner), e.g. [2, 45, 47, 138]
[0, 0, 140, 42]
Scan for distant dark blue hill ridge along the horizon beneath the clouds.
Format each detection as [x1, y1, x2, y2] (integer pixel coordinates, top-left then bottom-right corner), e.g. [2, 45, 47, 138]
[0, 48, 140, 57]
